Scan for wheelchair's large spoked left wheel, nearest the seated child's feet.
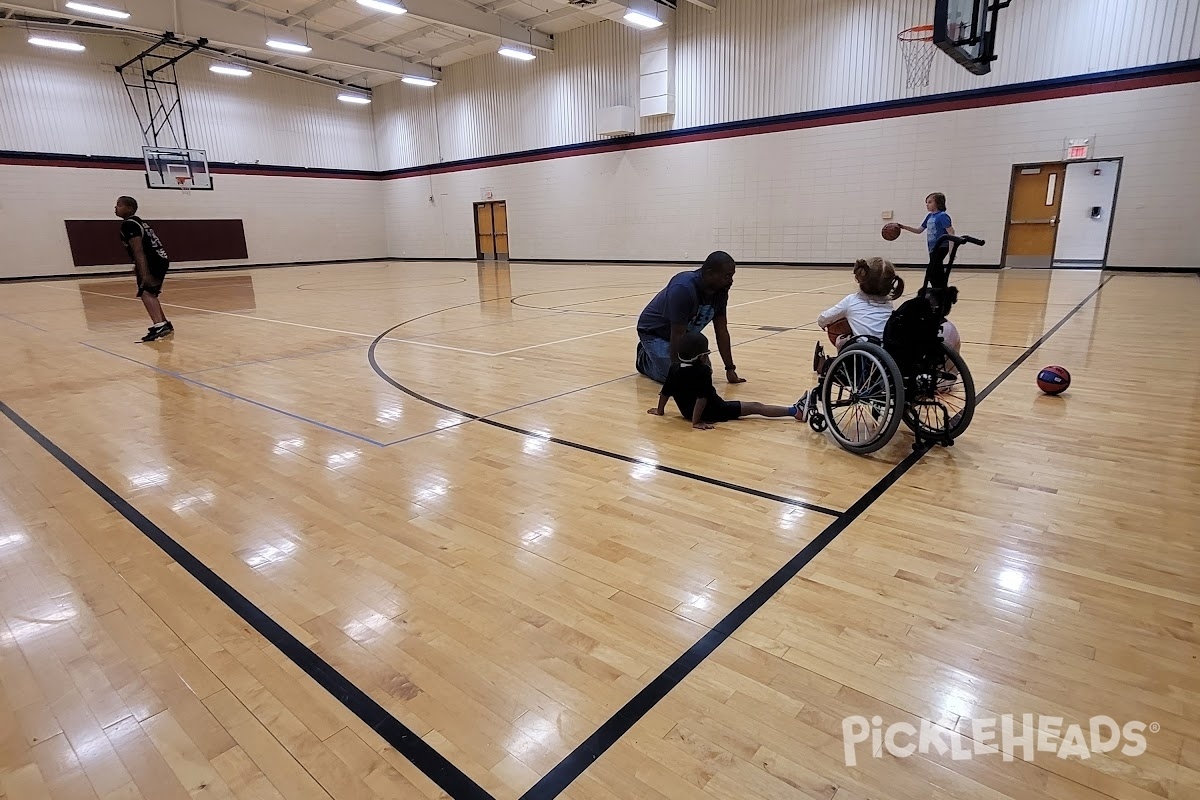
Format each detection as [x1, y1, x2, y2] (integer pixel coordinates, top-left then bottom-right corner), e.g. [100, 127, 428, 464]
[821, 343, 905, 456]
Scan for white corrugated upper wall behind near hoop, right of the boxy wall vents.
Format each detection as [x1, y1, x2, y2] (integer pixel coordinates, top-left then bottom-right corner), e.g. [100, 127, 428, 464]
[674, 0, 1200, 127]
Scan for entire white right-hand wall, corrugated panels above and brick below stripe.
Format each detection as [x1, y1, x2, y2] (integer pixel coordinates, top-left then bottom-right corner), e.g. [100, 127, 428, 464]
[376, 0, 1200, 266]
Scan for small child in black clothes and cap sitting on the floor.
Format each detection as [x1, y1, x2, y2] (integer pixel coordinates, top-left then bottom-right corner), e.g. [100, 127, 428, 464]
[647, 333, 799, 431]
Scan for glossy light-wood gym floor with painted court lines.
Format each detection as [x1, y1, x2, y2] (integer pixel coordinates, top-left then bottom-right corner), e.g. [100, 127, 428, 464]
[0, 263, 1200, 800]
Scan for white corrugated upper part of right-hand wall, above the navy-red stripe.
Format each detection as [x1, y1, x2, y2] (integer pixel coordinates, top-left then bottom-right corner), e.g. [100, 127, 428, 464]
[374, 0, 1200, 169]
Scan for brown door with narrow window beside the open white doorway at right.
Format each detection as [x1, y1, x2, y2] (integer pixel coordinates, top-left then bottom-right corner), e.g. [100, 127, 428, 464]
[1004, 164, 1067, 266]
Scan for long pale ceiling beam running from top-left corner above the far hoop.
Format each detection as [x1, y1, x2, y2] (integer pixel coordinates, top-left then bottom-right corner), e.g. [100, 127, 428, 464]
[0, 0, 440, 77]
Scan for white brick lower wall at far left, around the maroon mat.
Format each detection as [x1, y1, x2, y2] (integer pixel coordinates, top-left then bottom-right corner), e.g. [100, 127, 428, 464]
[0, 166, 388, 277]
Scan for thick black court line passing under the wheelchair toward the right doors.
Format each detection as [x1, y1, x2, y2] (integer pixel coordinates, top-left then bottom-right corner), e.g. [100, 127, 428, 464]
[521, 279, 1108, 800]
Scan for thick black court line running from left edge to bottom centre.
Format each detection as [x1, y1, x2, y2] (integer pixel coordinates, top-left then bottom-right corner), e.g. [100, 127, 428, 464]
[0, 401, 493, 800]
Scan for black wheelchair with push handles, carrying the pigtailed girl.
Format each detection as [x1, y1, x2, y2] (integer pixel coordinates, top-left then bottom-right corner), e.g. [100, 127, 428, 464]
[809, 234, 984, 456]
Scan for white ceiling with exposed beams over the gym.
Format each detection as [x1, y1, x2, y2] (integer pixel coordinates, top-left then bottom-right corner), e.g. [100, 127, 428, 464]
[0, 0, 691, 86]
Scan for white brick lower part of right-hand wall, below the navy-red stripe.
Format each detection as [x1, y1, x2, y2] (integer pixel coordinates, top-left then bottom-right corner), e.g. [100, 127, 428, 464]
[384, 83, 1200, 266]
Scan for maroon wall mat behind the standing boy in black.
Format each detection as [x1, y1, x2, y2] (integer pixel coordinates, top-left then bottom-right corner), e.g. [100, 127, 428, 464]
[64, 218, 248, 266]
